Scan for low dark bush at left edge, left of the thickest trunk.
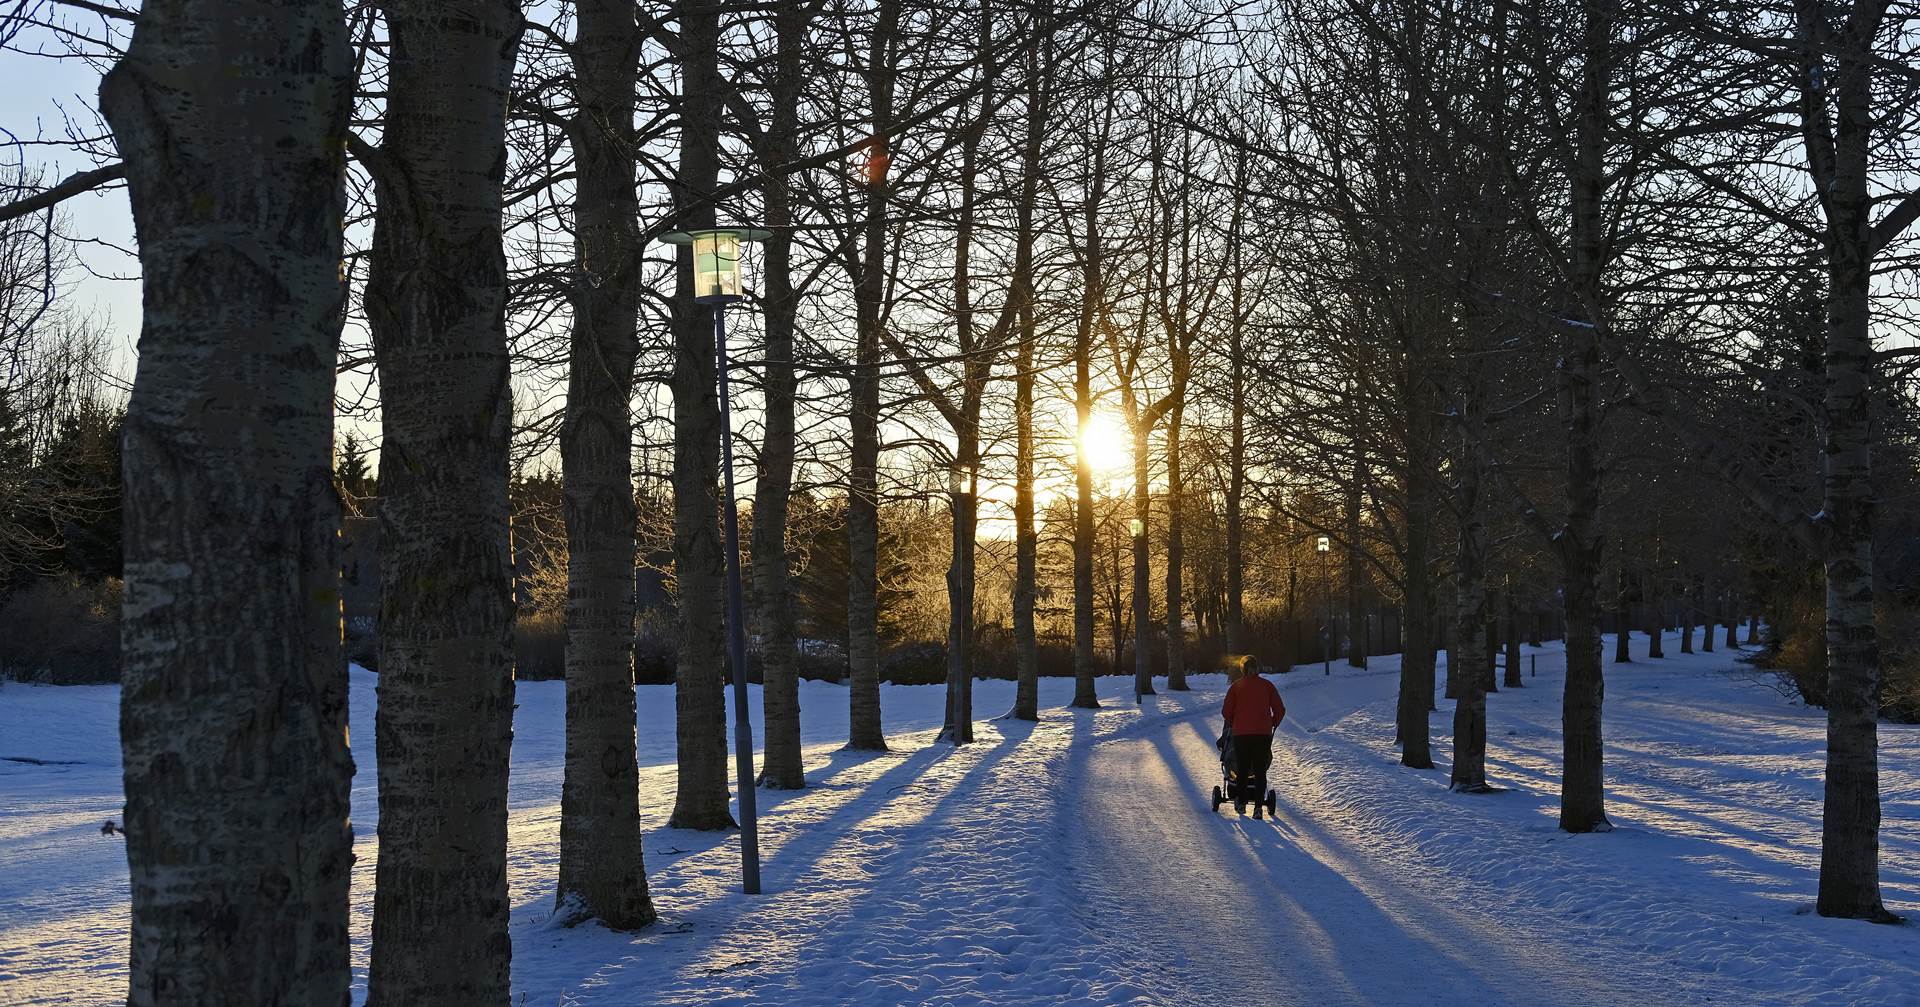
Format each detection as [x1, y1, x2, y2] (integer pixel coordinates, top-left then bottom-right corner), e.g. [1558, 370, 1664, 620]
[0, 575, 121, 686]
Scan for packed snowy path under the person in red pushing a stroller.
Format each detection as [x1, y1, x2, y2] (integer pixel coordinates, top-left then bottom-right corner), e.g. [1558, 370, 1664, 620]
[1066, 671, 1628, 1007]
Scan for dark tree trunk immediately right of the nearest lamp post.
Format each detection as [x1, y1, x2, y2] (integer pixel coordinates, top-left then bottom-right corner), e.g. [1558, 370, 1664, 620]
[748, 4, 810, 790]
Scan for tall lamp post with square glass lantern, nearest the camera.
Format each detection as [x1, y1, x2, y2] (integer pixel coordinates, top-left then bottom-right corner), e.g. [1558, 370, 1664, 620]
[660, 227, 772, 896]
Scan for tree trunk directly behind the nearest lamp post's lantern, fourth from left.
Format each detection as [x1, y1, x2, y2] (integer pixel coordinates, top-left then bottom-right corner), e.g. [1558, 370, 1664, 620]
[666, 0, 733, 830]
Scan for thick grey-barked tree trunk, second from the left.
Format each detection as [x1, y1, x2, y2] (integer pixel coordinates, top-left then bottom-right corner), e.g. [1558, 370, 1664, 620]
[367, 0, 522, 1005]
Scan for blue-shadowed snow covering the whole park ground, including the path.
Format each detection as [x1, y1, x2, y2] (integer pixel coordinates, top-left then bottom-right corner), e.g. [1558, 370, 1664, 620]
[0, 638, 1920, 1005]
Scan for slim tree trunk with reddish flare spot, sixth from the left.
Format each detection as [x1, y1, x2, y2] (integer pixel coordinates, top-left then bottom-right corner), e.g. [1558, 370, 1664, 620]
[847, 0, 900, 751]
